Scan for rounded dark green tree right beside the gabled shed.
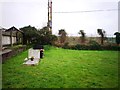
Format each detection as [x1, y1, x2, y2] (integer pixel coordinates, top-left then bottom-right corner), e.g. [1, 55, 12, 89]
[20, 25, 39, 44]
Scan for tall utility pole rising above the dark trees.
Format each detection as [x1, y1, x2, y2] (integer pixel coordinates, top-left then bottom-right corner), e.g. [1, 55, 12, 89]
[47, 0, 52, 34]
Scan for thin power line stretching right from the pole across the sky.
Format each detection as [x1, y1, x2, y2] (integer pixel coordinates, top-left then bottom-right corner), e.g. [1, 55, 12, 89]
[53, 9, 119, 13]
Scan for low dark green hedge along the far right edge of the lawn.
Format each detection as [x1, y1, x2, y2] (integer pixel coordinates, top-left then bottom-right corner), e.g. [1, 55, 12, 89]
[55, 40, 120, 51]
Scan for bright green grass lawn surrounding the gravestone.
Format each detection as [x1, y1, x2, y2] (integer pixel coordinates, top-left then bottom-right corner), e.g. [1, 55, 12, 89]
[2, 46, 118, 88]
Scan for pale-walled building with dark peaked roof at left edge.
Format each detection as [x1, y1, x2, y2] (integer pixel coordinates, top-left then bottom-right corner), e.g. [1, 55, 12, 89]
[0, 26, 22, 46]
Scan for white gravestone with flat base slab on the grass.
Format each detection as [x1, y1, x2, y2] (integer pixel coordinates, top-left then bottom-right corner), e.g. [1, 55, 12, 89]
[23, 48, 40, 65]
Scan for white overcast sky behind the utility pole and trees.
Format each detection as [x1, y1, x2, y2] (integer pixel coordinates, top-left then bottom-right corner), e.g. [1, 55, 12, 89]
[0, 0, 119, 36]
